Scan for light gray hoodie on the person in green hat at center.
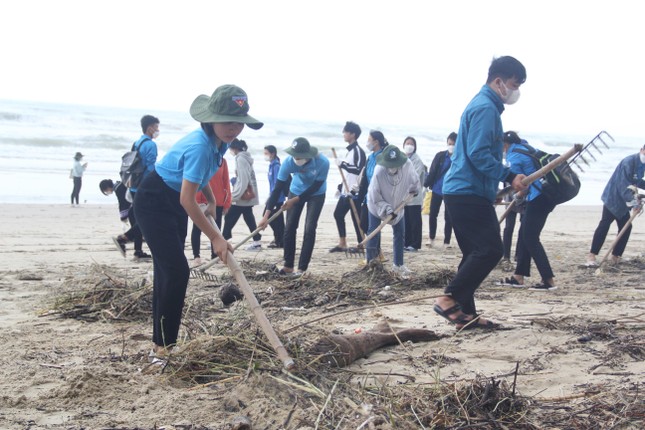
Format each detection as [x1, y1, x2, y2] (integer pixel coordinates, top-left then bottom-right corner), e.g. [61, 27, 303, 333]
[367, 160, 421, 225]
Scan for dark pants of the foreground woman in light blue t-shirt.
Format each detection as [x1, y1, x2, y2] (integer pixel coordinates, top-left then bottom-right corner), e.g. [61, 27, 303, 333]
[134, 171, 190, 346]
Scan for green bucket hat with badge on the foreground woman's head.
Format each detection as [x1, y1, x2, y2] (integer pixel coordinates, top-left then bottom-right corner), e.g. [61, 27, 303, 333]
[190, 85, 264, 130]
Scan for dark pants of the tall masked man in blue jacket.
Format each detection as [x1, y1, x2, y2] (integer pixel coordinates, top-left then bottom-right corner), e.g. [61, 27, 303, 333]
[442, 195, 503, 315]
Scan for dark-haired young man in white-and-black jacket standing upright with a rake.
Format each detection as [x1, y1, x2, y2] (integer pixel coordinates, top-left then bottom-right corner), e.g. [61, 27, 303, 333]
[329, 121, 366, 252]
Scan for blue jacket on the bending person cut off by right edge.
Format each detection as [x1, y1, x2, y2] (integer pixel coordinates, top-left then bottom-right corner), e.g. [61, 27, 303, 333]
[601, 154, 645, 218]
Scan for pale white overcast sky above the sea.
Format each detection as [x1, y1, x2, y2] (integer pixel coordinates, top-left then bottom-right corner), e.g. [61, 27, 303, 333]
[0, 0, 645, 138]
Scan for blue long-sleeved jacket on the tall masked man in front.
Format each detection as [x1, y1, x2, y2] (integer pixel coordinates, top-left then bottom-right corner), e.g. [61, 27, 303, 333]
[443, 85, 510, 203]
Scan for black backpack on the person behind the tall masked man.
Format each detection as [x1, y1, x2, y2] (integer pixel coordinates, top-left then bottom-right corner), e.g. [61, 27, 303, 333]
[513, 143, 580, 205]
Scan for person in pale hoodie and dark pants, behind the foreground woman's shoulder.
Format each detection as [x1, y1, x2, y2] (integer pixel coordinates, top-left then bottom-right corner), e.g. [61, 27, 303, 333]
[222, 139, 262, 251]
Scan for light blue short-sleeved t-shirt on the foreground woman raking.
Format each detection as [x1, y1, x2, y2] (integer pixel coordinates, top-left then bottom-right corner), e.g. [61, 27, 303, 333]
[155, 128, 228, 192]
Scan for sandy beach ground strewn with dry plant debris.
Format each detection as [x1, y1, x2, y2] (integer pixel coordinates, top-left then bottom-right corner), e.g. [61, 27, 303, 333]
[0, 203, 645, 429]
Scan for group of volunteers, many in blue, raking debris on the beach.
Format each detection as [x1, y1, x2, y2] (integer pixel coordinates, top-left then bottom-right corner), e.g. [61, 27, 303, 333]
[88, 56, 645, 356]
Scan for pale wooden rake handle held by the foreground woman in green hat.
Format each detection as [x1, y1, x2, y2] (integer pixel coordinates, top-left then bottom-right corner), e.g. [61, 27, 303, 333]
[208, 215, 296, 370]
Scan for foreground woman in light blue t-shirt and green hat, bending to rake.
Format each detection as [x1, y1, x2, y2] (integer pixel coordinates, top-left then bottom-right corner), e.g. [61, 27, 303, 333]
[134, 85, 264, 357]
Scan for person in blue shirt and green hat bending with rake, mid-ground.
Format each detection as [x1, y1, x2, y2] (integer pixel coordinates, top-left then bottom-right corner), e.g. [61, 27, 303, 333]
[258, 137, 329, 276]
